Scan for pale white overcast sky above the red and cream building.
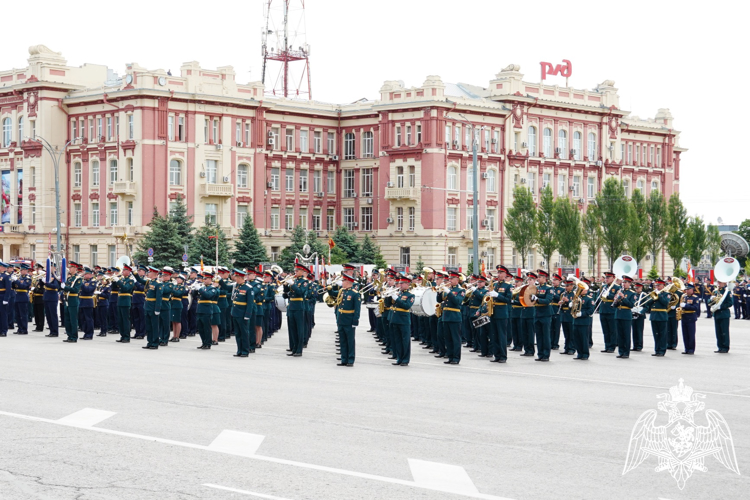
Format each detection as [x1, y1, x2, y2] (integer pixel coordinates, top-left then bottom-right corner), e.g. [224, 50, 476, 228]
[0, 0, 750, 224]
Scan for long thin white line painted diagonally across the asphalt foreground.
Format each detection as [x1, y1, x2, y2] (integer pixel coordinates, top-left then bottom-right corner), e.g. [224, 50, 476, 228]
[0, 411, 511, 500]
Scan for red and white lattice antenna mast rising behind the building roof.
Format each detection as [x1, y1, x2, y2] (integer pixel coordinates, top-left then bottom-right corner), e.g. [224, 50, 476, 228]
[261, 0, 312, 99]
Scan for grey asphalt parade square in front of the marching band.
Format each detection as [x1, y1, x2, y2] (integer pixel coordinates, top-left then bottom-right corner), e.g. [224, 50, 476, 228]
[0, 305, 750, 500]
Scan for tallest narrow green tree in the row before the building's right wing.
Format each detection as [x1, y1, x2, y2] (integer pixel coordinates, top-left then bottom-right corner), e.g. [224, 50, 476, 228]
[596, 177, 628, 267]
